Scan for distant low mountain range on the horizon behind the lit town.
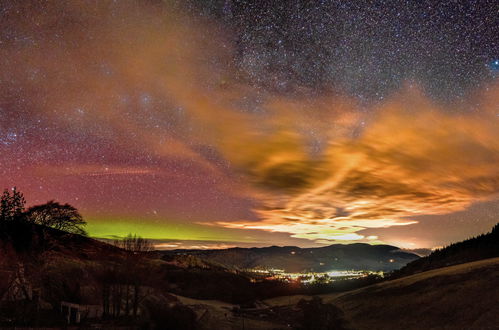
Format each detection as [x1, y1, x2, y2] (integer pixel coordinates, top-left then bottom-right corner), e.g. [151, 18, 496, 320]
[161, 243, 419, 272]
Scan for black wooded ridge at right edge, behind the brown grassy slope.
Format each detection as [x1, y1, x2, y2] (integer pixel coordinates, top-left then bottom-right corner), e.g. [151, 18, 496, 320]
[394, 223, 499, 277]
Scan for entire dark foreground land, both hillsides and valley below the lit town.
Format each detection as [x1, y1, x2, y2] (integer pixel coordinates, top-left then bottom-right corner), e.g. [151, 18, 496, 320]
[0, 222, 499, 330]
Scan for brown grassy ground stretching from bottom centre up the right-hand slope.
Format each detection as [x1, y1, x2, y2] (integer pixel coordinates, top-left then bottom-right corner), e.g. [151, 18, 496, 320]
[162, 258, 499, 330]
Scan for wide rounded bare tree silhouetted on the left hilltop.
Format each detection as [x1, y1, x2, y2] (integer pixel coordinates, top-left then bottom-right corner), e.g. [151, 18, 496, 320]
[26, 201, 87, 235]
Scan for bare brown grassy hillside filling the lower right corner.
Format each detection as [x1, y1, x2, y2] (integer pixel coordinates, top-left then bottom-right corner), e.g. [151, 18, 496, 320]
[324, 258, 499, 329]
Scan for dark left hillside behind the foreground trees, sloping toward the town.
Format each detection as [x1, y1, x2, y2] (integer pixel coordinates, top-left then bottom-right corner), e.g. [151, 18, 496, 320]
[0, 223, 278, 306]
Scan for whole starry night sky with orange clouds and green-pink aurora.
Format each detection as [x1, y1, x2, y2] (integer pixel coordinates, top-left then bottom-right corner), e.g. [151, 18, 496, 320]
[0, 0, 499, 249]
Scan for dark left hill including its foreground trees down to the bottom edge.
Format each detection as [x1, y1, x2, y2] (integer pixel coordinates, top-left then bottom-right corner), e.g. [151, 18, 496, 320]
[0, 222, 257, 329]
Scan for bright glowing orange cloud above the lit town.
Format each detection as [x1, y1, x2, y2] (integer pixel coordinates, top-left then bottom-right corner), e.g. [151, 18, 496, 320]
[220, 88, 499, 241]
